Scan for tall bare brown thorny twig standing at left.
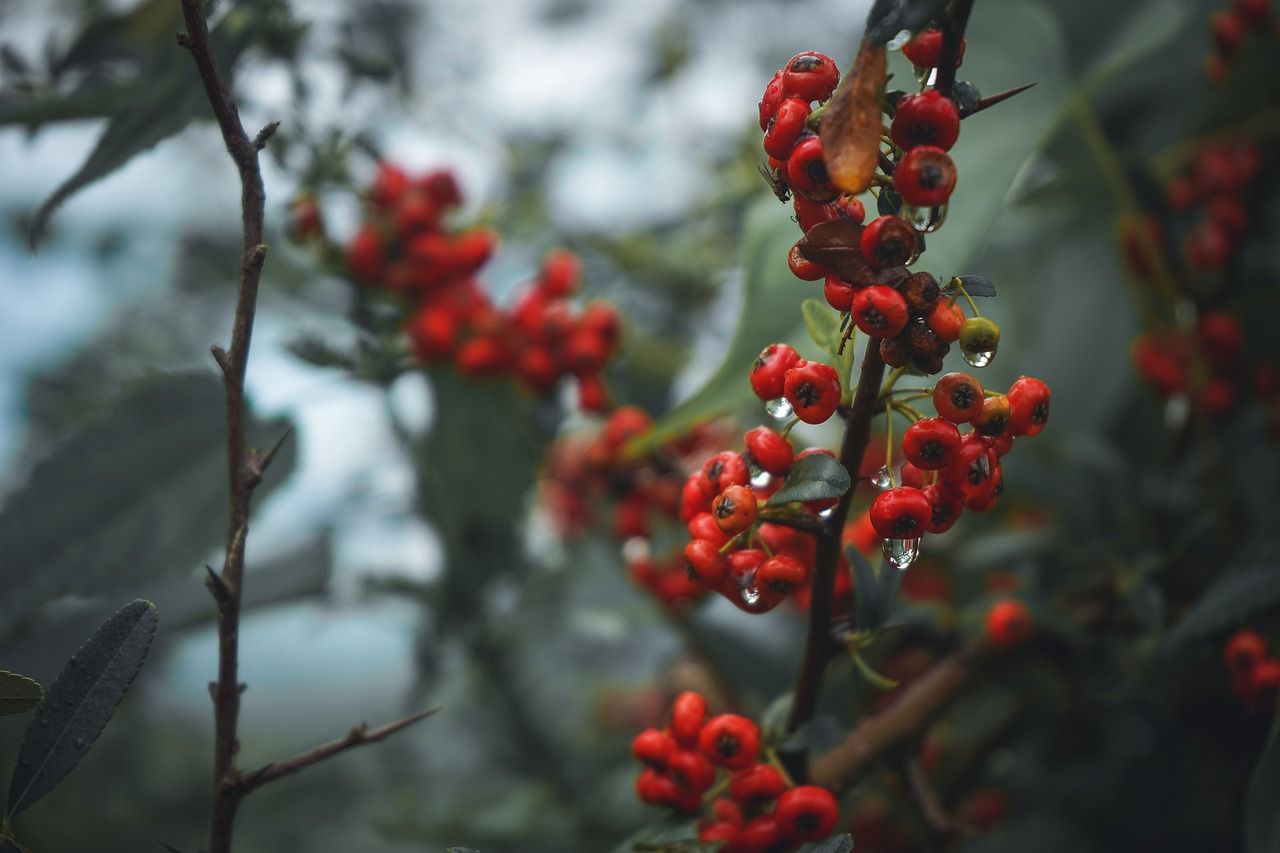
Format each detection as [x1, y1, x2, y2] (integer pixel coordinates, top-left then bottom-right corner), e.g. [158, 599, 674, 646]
[178, 0, 274, 853]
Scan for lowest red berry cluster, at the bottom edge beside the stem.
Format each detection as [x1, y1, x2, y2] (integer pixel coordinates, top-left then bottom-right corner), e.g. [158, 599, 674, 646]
[631, 692, 840, 853]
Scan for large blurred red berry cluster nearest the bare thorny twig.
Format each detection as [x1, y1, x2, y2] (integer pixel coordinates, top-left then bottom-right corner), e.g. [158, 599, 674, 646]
[335, 163, 621, 411]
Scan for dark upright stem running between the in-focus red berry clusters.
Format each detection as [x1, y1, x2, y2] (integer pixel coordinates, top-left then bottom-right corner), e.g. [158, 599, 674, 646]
[787, 341, 884, 731]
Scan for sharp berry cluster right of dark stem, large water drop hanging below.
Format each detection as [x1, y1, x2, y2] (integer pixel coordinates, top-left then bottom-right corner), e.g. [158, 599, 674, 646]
[870, 373, 1050, 567]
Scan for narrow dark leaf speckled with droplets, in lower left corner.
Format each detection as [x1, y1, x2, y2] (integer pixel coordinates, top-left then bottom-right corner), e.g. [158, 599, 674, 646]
[5, 599, 157, 820]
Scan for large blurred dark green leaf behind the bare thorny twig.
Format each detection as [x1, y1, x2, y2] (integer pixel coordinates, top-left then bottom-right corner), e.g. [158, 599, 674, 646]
[0, 370, 296, 635]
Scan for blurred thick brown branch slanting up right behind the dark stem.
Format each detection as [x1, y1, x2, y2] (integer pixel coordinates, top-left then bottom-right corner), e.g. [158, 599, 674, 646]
[809, 643, 987, 797]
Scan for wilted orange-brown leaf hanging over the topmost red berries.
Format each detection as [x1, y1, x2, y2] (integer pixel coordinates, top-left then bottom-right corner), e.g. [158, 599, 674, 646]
[818, 41, 888, 195]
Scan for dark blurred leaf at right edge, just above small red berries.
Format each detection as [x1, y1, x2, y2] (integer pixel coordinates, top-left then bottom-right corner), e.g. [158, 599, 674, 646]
[1161, 532, 1280, 654]
